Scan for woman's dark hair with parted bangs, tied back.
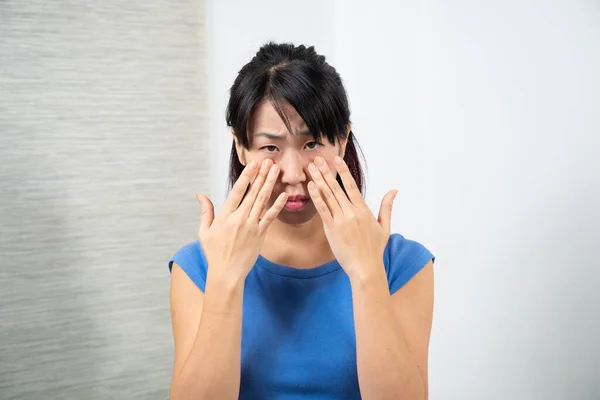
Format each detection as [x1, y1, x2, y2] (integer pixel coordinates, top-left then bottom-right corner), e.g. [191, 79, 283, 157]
[226, 42, 365, 194]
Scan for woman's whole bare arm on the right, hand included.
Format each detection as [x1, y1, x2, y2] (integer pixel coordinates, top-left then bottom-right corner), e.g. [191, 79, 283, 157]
[308, 157, 433, 400]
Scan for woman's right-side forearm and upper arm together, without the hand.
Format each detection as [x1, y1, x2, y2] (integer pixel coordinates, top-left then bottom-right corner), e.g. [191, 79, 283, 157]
[350, 261, 433, 400]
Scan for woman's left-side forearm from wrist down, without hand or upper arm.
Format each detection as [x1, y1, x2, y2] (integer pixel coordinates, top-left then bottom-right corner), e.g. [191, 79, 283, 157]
[171, 273, 244, 400]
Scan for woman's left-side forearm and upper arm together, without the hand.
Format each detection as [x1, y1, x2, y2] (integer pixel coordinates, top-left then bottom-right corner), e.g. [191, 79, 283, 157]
[171, 263, 244, 400]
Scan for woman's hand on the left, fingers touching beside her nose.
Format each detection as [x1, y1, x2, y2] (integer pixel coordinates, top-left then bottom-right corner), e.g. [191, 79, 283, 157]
[197, 159, 287, 282]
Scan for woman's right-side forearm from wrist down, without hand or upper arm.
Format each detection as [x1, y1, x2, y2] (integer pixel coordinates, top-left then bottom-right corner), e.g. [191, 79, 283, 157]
[350, 266, 426, 400]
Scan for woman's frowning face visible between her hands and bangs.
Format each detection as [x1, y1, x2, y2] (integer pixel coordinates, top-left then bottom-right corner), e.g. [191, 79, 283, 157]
[236, 101, 346, 224]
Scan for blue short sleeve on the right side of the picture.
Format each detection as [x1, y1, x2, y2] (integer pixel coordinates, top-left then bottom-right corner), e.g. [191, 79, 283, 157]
[383, 233, 435, 294]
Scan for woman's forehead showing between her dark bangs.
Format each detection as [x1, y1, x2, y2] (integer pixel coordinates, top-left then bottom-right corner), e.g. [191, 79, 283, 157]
[248, 100, 306, 136]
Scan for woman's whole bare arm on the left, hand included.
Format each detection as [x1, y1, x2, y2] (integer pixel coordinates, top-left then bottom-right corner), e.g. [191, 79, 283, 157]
[171, 159, 287, 400]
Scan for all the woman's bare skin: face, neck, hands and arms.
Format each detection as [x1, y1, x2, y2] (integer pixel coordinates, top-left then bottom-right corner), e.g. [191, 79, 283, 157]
[171, 102, 433, 400]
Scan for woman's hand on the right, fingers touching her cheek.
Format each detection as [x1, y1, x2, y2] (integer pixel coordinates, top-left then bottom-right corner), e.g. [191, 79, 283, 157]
[308, 157, 398, 279]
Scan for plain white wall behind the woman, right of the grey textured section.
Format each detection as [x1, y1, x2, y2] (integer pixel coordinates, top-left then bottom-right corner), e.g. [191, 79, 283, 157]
[208, 0, 600, 400]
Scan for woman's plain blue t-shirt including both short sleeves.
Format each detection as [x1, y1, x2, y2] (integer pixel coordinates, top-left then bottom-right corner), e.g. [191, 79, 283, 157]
[169, 234, 434, 400]
